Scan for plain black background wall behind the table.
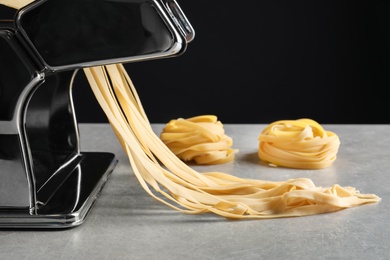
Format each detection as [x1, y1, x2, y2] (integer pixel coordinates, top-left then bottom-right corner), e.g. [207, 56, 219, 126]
[1, 0, 390, 124]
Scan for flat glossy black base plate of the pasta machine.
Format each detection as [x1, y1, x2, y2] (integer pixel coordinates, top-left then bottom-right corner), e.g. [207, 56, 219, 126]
[0, 152, 117, 229]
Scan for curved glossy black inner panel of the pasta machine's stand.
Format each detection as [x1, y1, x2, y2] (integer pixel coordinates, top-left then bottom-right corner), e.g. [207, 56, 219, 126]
[25, 71, 79, 194]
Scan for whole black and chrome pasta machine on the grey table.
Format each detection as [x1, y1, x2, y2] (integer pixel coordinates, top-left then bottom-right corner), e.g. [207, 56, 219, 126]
[0, 0, 195, 229]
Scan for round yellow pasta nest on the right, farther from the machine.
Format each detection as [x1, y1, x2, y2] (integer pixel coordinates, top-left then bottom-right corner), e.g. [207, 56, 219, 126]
[258, 118, 340, 169]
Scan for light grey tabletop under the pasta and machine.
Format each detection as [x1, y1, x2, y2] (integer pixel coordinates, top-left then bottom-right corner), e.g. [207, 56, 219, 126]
[0, 124, 390, 260]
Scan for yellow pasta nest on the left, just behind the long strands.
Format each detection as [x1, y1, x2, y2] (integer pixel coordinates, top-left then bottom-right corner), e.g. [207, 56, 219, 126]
[160, 115, 237, 164]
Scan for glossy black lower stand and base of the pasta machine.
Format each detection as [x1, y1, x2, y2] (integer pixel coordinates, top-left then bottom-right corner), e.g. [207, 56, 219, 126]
[0, 27, 116, 228]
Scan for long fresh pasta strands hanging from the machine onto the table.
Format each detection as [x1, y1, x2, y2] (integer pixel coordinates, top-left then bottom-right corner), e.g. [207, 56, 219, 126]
[0, 0, 380, 219]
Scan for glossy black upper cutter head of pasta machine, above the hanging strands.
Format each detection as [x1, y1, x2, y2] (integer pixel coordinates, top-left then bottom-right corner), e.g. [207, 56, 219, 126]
[16, 0, 192, 71]
